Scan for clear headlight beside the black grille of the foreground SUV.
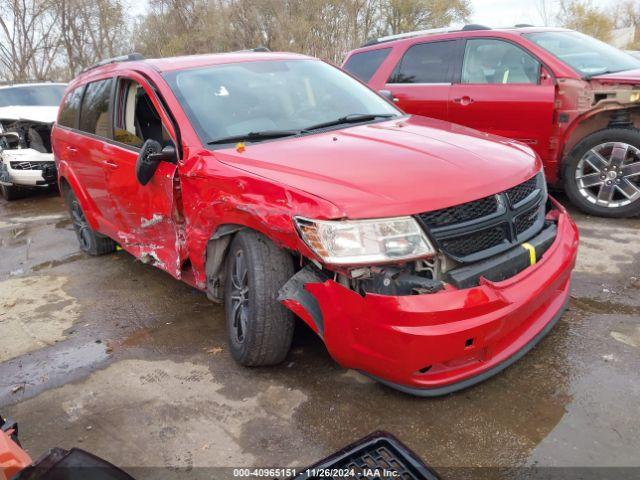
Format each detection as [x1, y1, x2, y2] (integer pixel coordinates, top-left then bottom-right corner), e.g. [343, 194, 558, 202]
[295, 217, 435, 265]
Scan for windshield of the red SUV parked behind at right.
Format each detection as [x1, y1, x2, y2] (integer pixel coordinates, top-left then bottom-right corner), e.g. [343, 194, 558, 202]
[525, 32, 640, 77]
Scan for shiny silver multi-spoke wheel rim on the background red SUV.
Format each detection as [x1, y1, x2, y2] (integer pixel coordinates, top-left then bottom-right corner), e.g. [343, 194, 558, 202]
[575, 142, 640, 208]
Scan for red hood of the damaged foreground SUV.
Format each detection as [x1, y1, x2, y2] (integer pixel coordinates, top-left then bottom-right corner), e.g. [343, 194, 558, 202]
[215, 116, 542, 218]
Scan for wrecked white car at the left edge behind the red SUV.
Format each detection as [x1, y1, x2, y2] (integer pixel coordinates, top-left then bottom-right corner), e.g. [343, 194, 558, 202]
[0, 83, 66, 200]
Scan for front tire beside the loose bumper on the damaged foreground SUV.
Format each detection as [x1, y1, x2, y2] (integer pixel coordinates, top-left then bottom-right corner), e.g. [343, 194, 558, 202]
[225, 230, 295, 367]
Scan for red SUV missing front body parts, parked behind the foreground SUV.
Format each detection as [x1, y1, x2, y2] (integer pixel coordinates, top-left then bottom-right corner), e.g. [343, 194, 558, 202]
[343, 25, 640, 217]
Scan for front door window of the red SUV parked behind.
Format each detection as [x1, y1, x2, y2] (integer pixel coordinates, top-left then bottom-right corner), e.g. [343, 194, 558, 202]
[462, 38, 540, 84]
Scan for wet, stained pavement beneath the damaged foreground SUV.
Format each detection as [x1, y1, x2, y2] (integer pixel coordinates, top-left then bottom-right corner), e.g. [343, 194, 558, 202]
[0, 190, 640, 478]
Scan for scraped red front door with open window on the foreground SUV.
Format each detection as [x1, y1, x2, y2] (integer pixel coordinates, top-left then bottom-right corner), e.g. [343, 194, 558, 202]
[105, 71, 186, 278]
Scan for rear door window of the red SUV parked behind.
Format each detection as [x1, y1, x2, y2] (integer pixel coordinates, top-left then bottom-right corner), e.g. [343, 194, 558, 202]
[389, 40, 457, 83]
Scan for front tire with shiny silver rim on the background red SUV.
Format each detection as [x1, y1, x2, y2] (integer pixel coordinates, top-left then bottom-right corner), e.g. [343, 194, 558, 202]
[563, 128, 640, 217]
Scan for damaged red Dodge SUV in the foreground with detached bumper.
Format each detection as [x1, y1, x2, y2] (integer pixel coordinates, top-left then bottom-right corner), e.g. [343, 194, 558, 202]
[53, 52, 578, 396]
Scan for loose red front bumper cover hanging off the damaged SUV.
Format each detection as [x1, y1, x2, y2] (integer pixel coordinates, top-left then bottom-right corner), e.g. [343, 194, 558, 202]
[281, 201, 578, 396]
